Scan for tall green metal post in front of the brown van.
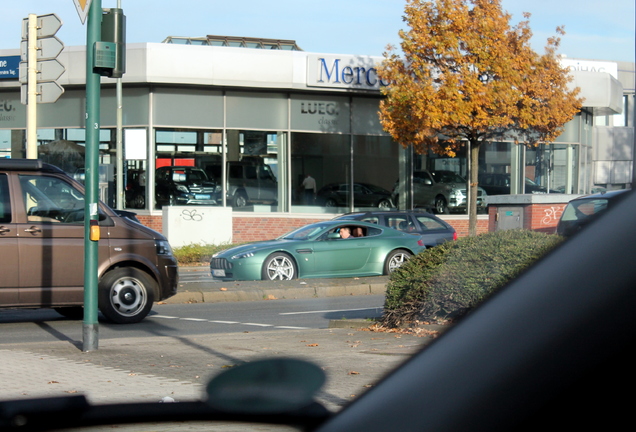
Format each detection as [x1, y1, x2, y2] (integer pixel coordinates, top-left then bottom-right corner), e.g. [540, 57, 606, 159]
[82, 0, 102, 351]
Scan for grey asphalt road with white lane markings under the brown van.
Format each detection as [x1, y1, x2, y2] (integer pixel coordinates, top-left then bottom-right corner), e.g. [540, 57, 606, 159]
[0, 295, 384, 346]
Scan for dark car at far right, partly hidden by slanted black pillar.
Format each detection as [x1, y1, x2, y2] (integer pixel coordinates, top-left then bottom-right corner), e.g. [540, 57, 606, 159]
[557, 189, 630, 237]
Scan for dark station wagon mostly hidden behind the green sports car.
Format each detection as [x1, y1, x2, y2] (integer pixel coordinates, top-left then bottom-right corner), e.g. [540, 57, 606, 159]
[334, 210, 457, 248]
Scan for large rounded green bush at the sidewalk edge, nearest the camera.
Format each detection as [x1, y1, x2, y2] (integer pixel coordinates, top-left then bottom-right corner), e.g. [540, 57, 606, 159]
[382, 230, 561, 327]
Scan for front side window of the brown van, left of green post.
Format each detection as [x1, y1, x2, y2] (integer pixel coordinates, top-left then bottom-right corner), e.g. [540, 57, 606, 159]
[19, 175, 84, 223]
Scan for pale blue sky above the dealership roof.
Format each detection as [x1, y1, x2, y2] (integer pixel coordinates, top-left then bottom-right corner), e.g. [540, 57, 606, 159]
[0, 0, 636, 62]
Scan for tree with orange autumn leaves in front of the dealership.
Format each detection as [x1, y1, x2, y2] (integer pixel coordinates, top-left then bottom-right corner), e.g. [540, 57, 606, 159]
[378, 0, 582, 235]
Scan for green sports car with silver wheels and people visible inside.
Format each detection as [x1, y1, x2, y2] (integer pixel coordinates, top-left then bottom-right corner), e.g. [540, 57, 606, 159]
[210, 220, 426, 280]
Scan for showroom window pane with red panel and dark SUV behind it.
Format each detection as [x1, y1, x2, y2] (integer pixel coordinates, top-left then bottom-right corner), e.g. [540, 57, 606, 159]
[153, 129, 223, 209]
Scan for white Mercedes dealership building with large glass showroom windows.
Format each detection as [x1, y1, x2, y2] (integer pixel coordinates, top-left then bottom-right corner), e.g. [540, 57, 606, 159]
[0, 36, 634, 238]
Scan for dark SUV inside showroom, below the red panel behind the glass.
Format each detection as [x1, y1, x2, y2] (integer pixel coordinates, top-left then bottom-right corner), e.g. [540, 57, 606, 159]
[155, 166, 217, 208]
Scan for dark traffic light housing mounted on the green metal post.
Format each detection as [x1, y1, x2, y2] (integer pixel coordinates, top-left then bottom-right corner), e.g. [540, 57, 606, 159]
[93, 8, 126, 78]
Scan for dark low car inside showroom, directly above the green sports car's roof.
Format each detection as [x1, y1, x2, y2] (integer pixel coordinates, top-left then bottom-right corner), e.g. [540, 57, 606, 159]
[316, 183, 393, 209]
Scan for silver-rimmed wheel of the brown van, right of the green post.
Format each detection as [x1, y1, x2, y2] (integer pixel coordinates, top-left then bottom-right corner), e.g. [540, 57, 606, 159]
[99, 267, 156, 324]
